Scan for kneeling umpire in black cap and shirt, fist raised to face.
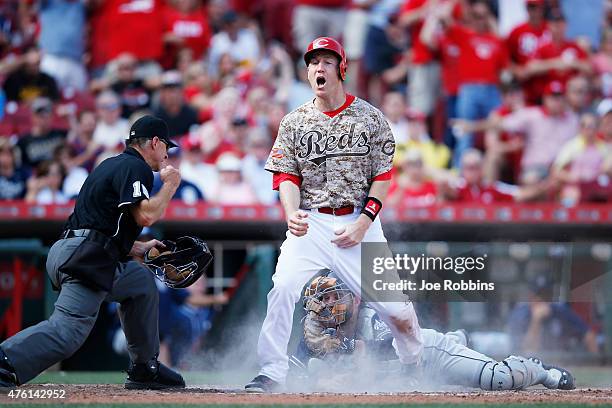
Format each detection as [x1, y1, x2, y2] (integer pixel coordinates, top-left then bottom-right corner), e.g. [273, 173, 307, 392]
[0, 116, 185, 389]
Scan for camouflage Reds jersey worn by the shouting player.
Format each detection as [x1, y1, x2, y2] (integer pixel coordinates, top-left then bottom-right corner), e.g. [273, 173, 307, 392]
[265, 98, 395, 208]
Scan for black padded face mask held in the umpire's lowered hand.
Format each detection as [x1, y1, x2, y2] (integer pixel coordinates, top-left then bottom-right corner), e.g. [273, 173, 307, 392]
[144, 237, 213, 288]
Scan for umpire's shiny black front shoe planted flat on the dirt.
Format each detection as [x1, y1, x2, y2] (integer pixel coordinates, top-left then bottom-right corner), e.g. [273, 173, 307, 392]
[125, 358, 185, 390]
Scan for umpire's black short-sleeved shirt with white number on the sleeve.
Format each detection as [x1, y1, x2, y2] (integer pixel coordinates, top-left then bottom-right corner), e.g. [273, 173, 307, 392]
[66, 147, 153, 256]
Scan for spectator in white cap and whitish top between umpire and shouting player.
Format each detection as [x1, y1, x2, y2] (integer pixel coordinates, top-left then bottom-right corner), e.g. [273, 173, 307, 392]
[210, 153, 259, 205]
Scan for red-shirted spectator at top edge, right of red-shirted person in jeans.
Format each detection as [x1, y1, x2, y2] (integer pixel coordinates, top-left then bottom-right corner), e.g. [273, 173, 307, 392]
[506, 0, 550, 103]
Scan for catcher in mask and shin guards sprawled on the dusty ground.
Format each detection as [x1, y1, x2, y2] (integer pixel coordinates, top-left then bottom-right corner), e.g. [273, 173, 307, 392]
[290, 269, 575, 391]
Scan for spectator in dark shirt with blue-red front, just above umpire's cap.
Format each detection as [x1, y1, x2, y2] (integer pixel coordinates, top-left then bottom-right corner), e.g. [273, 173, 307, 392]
[110, 53, 154, 119]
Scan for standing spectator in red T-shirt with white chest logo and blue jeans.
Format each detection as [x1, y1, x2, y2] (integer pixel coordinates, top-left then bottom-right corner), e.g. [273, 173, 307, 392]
[438, 0, 508, 167]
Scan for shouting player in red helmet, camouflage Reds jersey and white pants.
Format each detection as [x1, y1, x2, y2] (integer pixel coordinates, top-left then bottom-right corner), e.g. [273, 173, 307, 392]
[245, 37, 422, 392]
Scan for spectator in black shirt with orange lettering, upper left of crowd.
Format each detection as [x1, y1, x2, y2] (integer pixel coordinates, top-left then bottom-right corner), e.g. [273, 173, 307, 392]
[2, 47, 60, 103]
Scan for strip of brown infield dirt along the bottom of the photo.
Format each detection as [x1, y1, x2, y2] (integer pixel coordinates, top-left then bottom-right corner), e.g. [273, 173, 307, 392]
[0, 384, 612, 406]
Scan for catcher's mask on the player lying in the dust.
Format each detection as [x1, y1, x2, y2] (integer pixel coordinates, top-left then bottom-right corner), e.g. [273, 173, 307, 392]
[304, 269, 355, 326]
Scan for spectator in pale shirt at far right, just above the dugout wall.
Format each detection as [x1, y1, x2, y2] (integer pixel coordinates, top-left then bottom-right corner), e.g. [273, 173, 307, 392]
[553, 113, 607, 204]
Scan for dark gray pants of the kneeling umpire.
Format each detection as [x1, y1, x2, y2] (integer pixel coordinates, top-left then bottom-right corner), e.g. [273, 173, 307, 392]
[0, 237, 159, 384]
